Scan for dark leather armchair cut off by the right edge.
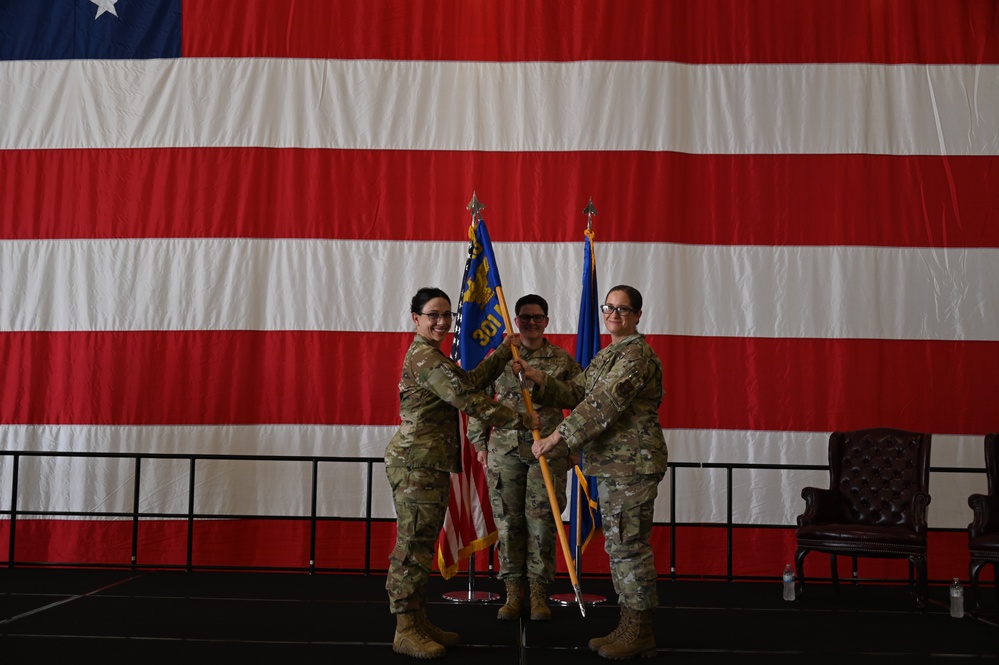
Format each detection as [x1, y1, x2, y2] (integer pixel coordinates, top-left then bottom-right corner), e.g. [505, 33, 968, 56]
[968, 433, 999, 613]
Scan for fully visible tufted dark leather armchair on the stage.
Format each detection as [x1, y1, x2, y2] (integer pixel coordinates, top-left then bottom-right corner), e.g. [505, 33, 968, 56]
[795, 427, 932, 608]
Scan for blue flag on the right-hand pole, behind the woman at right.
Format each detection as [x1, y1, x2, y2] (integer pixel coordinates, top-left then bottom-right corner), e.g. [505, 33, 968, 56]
[569, 229, 601, 568]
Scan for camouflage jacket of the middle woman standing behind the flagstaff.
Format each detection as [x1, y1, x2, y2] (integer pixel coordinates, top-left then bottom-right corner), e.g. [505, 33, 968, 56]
[468, 339, 583, 461]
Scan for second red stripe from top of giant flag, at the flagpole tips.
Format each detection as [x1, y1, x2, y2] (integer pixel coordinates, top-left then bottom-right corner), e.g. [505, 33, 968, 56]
[0, 148, 999, 247]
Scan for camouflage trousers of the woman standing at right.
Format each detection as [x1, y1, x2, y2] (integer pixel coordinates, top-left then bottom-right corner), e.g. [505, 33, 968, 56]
[597, 474, 665, 610]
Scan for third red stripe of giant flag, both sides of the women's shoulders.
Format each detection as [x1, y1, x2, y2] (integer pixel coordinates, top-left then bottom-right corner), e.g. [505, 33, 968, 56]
[0, 331, 999, 434]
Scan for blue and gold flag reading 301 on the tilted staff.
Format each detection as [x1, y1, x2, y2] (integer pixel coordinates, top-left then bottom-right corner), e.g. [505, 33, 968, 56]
[451, 220, 506, 370]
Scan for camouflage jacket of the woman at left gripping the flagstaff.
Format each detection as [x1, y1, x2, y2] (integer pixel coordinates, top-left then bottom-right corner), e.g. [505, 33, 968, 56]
[385, 335, 531, 473]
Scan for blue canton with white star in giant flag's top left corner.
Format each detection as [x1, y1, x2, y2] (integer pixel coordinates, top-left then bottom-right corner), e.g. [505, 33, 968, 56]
[0, 0, 181, 60]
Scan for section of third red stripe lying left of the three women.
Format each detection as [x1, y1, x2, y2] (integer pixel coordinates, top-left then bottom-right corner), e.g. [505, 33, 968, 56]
[0, 330, 413, 425]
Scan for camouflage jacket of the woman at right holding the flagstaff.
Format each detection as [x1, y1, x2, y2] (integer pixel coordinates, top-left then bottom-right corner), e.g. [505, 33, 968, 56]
[535, 333, 668, 476]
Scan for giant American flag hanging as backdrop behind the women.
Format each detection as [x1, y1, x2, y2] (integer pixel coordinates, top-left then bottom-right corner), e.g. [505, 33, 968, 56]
[0, 0, 999, 578]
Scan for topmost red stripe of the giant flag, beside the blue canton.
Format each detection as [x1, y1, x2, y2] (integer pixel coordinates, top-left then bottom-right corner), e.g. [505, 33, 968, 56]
[183, 0, 999, 64]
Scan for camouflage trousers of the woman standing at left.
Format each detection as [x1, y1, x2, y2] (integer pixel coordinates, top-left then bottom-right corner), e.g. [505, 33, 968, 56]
[385, 466, 451, 614]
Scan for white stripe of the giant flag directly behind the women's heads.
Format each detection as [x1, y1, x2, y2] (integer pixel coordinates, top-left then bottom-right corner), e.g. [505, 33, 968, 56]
[0, 238, 999, 341]
